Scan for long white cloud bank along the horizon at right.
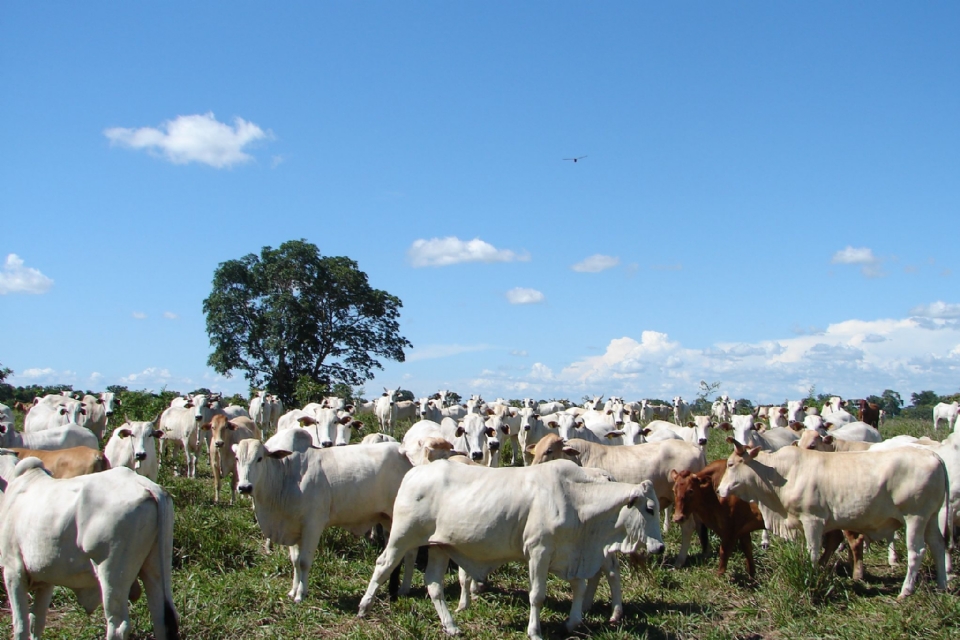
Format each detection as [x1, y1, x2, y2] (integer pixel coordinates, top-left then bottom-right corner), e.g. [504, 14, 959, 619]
[454, 305, 960, 402]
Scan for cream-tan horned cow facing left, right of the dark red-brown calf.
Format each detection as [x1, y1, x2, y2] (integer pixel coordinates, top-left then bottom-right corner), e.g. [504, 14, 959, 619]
[717, 442, 949, 598]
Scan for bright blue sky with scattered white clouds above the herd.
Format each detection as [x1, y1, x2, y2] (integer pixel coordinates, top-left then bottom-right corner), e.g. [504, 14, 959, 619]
[0, 2, 960, 401]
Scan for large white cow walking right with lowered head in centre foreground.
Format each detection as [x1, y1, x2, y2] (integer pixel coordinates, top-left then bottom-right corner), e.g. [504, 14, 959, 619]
[358, 460, 663, 640]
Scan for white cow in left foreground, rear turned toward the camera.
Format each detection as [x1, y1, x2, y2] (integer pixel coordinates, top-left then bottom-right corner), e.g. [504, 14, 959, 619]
[0, 458, 179, 640]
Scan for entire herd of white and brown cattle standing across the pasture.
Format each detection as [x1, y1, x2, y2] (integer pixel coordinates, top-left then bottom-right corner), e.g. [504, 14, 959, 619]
[0, 389, 960, 640]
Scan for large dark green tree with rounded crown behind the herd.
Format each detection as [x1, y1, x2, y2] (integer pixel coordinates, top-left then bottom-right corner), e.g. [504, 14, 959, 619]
[203, 240, 411, 403]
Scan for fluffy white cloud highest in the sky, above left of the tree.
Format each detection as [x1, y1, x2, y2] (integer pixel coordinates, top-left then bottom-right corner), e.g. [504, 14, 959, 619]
[103, 112, 273, 169]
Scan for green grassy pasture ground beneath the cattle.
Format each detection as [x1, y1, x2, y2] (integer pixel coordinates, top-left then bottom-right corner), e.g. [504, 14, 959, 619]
[0, 416, 960, 640]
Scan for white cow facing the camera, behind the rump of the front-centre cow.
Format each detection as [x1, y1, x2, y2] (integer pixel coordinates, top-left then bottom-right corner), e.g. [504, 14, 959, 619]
[233, 440, 414, 602]
